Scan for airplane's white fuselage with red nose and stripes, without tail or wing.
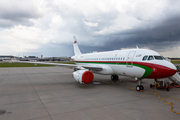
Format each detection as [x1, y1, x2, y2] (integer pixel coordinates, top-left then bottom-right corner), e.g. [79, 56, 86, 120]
[72, 49, 176, 78]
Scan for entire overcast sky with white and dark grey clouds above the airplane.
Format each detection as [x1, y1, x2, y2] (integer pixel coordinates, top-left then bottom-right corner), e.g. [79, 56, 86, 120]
[0, 0, 180, 57]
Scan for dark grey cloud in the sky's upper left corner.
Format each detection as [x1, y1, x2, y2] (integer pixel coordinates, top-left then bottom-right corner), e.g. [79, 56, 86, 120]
[0, 0, 42, 28]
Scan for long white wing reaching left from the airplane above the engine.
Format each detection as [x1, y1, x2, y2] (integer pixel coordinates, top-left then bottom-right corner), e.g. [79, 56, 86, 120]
[16, 61, 103, 71]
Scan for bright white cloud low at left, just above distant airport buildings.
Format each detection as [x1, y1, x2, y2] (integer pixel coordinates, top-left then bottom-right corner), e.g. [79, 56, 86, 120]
[0, 25, 51, 54]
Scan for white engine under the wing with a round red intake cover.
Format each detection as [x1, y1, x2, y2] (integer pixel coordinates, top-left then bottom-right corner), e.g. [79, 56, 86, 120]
[73, 69, 94, 84]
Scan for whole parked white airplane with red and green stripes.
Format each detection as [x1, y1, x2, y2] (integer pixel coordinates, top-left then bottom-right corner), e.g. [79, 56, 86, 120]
[15, 36, 177, 91]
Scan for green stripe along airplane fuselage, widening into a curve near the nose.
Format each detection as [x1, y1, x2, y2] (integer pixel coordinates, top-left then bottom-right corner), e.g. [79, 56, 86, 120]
[76, 62, 153, 78]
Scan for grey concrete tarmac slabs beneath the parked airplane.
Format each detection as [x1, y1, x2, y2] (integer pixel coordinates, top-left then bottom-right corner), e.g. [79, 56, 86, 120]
[0, 67, 180, 120]
